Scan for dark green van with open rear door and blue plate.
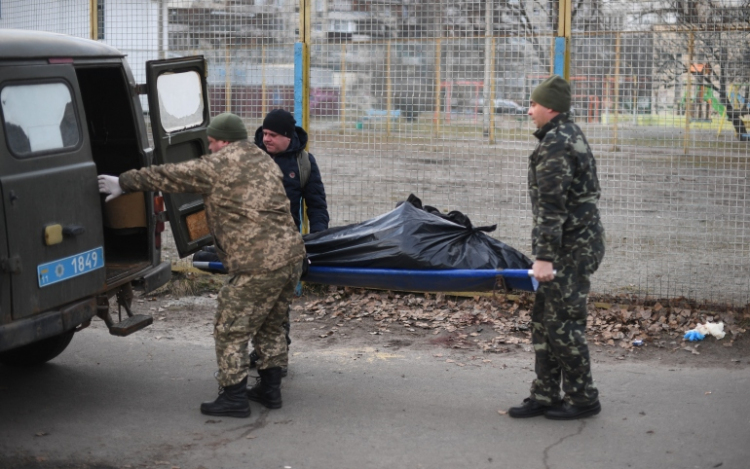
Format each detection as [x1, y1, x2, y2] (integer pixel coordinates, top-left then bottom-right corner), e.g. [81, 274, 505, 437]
[0, 29, 211, 366]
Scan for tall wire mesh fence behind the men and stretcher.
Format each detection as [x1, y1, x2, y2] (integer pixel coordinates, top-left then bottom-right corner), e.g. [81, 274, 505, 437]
[0, 0, 750, 305]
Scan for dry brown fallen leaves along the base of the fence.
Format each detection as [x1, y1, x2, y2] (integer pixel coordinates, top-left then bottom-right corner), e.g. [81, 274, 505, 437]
[294, 287, 750, 353]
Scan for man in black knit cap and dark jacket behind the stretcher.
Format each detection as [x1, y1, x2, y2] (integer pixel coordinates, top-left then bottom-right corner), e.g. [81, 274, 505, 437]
[255, 109, 329, 233]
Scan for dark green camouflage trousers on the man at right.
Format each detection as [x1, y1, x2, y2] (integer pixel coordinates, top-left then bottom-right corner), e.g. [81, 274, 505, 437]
[531, 241, 604, 405]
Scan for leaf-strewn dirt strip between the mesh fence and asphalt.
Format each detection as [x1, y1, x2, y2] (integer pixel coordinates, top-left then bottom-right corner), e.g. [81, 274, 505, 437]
[101, 272, 750, 368]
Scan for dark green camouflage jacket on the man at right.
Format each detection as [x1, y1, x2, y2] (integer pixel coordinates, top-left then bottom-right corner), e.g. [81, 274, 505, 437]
[528, 113, 604, 262]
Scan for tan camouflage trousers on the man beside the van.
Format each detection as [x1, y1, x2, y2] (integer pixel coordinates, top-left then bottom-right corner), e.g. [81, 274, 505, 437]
[214, 262, 302, 387]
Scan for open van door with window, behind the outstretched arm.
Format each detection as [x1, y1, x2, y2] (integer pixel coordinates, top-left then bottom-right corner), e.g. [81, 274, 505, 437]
[146, 56, 213, 257]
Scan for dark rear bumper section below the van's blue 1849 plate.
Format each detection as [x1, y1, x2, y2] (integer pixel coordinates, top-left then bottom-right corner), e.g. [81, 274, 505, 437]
[0, 296, 96, 352]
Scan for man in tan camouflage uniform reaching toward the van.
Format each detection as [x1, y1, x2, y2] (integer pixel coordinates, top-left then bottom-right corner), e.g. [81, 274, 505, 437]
[99, 113, 305, 417]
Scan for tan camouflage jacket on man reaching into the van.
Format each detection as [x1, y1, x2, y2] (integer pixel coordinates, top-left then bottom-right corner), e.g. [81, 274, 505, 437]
[120, 140, 305, 274]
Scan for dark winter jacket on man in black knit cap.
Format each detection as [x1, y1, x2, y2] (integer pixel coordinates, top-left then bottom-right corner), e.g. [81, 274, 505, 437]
[255, 126, 329, 233]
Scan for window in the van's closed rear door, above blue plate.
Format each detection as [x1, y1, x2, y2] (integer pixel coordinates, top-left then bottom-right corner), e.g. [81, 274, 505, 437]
[0, 83, 80, 157]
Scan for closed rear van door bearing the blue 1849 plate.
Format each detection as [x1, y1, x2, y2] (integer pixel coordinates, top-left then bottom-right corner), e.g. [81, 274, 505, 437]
[0, 64, 105, 319]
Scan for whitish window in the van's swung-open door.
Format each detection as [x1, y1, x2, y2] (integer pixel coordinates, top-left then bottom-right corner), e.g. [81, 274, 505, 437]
[156, 72, 203, 132]
